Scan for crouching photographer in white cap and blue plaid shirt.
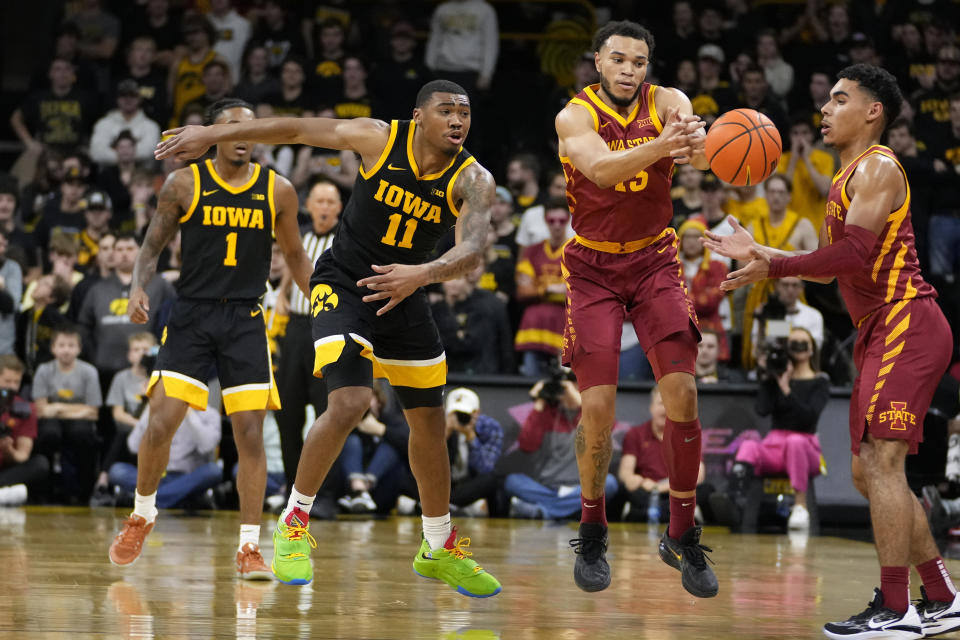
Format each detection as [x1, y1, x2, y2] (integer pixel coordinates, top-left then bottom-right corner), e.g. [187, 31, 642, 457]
[445, 387, 503, 516]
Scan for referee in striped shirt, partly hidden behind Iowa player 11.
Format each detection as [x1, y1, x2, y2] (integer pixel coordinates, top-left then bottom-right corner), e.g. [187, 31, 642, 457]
[276, 177, 343, 497]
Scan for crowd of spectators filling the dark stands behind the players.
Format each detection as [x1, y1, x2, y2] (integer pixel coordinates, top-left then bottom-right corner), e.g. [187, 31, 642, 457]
[0, 0, 960, 515]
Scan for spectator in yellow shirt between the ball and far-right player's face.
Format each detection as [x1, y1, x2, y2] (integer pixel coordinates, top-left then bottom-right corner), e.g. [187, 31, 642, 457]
[777, 117, 836, 229]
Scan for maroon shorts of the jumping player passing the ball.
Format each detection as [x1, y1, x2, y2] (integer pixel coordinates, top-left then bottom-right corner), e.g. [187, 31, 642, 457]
[562, 229, 700, 390]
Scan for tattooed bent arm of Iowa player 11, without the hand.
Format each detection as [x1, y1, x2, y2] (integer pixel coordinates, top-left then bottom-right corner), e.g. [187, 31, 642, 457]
[426, 164, 496, 282]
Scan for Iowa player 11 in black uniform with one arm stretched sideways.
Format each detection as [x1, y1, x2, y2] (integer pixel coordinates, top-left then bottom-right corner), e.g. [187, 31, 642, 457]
[156, 80, 500, 597]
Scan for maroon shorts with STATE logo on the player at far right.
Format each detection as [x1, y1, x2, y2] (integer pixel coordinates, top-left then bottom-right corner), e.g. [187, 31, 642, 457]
[850, 297, 953, 455]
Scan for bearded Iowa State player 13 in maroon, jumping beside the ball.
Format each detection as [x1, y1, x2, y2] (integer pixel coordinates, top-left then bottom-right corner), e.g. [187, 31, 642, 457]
[556, 21, 717, 598]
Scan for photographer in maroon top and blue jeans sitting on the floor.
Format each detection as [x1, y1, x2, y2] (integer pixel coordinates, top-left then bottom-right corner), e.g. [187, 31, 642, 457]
[504, 364, 617, 518]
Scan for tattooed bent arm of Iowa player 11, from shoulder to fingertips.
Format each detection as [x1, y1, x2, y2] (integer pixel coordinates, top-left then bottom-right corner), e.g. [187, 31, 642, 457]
[357, 163, 496, 316]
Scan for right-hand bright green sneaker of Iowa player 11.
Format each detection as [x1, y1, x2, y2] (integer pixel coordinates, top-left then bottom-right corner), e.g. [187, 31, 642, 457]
[413, 528, 503, 598]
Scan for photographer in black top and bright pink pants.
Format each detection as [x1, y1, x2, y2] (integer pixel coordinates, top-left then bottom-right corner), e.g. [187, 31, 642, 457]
[733, 327, 830, 531]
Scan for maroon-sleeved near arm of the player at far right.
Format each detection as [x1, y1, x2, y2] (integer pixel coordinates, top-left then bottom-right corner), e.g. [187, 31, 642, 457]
[721, 154, 907, 291]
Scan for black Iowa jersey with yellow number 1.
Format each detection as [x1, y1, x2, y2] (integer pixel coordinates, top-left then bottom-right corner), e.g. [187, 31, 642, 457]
[177, 160, 276, 300]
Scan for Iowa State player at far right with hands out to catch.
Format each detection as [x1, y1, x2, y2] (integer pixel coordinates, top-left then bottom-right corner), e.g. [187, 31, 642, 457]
[705, 64, 960, 638]
